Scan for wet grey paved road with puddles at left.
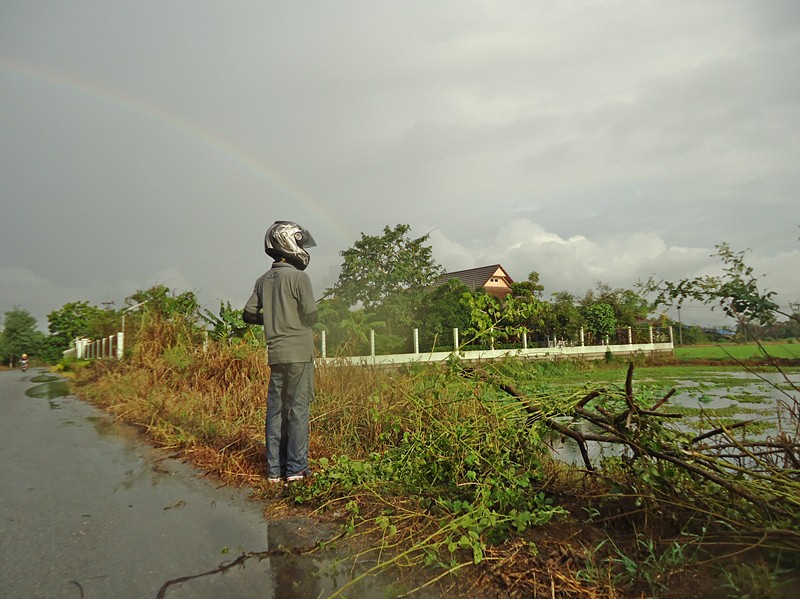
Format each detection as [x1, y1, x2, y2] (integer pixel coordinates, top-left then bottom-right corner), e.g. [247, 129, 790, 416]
[0, 370, 424, 599]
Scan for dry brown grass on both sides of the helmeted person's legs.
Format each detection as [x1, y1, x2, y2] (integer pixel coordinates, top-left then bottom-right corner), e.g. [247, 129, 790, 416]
[76, 321, 403, 489]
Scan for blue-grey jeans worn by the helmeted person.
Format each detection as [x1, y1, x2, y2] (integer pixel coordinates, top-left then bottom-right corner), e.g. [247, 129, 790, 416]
[265, 362, 314, 478]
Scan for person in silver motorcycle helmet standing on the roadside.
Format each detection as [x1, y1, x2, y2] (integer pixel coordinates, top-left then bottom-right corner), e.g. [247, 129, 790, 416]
[244, 221, 317, 483]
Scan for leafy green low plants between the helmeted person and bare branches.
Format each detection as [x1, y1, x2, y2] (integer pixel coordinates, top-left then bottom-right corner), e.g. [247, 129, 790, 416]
[295, 372, 566, 592]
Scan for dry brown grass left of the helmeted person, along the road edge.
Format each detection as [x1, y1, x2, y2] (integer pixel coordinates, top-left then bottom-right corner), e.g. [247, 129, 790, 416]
[77, 321, 269, 485]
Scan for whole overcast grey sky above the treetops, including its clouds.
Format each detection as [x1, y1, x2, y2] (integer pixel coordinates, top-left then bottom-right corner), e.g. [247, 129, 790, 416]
[0, 0, 800, 329]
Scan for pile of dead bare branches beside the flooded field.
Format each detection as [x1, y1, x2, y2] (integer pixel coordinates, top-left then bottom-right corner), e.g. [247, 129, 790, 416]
[469, 364, 800, 551]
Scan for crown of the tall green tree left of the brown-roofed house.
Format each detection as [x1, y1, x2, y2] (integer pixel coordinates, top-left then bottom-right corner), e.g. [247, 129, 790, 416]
[325, 225, 443, 309]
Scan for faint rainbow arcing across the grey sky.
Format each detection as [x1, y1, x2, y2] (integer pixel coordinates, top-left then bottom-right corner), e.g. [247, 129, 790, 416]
[0, 60, 354, 245]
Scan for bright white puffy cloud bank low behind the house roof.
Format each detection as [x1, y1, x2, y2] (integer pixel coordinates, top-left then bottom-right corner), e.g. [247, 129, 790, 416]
[430, 219, 800, 324]
